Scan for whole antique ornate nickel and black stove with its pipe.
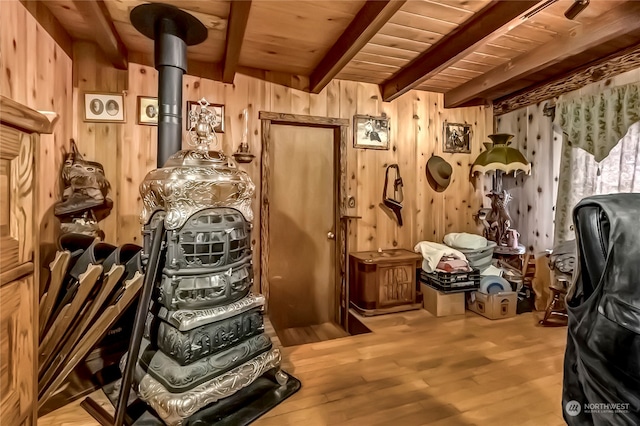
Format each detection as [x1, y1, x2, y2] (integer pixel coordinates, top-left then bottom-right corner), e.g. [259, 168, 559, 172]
[83, 4, 300, 426]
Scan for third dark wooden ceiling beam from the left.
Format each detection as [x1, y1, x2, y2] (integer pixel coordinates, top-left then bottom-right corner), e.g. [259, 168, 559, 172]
[309, 0, 405, 93]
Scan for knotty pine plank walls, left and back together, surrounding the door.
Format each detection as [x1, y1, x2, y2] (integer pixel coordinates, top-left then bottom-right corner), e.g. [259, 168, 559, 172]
[0, 1, 492, 292]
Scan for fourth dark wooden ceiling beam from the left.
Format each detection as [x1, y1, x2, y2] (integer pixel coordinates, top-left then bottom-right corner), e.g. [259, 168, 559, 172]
[380, 0, 539, 101]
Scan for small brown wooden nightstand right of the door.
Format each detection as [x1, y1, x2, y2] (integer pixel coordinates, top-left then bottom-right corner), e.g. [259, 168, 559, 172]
[349, 249, 422, 316]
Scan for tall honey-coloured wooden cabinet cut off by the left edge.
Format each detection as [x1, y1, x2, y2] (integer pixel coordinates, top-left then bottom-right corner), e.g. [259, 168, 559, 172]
[0, 96, 55, 425]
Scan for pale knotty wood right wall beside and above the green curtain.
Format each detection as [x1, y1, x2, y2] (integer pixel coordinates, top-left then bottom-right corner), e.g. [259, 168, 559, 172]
[496, 69, 640, 254]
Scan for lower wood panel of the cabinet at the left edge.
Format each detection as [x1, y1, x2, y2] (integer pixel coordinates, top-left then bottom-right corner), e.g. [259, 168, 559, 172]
[0, 275, 36, 425]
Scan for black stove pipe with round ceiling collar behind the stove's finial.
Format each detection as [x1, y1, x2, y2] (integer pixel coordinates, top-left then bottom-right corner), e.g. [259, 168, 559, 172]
[130, 3, 207, 168]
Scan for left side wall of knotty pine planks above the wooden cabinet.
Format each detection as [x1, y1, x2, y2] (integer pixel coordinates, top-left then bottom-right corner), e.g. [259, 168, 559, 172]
[0, 0, 74, 282]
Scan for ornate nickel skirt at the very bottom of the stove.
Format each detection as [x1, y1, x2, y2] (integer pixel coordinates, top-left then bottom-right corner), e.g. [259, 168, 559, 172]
[136, 349, 281, 426]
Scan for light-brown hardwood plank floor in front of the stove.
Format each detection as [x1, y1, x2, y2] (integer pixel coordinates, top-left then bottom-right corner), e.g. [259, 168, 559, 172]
[38, 310, 567, 426]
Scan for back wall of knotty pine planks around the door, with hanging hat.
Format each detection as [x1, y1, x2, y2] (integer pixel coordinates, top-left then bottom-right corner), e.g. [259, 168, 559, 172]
[74, 47, 492, 296]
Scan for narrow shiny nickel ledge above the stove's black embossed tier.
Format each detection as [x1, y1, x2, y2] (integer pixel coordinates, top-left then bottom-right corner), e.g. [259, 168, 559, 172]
[158, 294, 265, 331]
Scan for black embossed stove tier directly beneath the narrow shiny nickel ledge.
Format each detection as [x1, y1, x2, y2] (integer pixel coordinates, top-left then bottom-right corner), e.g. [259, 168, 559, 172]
[152, 308, 264, 365]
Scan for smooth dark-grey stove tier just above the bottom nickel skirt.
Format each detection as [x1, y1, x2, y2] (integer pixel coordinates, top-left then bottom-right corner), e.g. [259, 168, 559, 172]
[140, 334, 272, 393]
